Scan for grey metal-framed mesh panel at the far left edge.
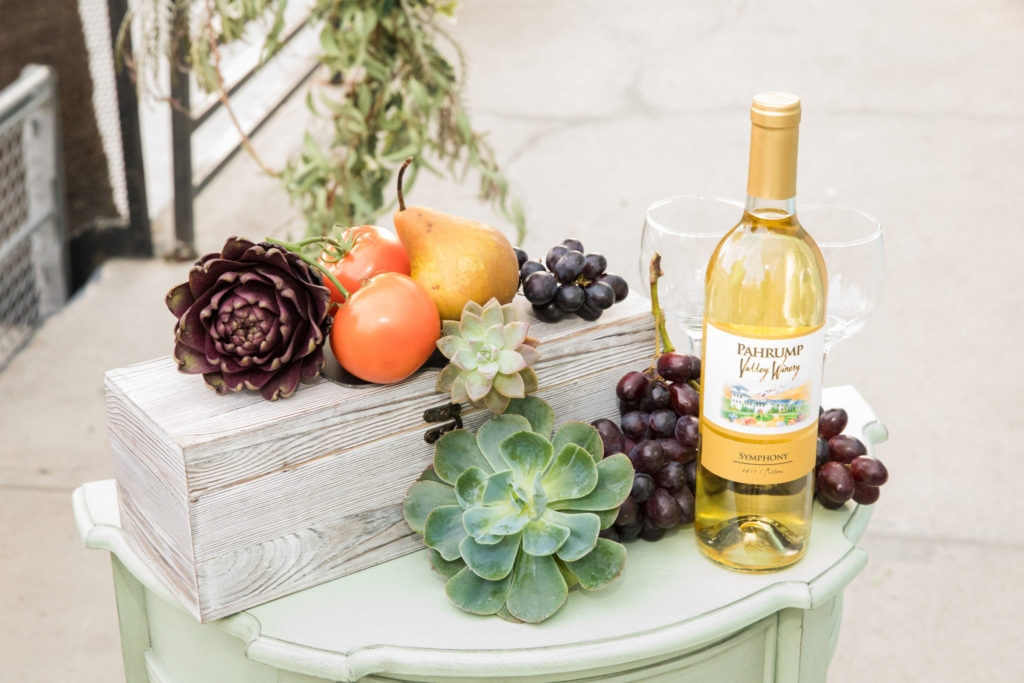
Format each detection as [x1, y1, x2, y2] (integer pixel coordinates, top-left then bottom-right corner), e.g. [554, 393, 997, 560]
[0, 65, 69, 371]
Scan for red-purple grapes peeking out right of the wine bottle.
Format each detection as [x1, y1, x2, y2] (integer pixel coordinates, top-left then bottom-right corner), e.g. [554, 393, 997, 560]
[814, 408, 889, 510]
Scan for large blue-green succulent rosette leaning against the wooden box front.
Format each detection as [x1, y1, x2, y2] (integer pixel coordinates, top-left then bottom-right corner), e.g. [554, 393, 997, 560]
[402, 397, 633, 623]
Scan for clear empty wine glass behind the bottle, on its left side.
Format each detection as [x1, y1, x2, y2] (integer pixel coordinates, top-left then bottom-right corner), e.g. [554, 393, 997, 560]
[640, 195, 743, 353]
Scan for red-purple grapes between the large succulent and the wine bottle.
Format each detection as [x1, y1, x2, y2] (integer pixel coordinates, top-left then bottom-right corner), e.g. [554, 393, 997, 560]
[594, 353, 700, 542]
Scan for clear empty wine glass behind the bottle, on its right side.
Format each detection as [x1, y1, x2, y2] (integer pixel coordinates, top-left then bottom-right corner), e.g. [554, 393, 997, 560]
[797, 204, 885, 355]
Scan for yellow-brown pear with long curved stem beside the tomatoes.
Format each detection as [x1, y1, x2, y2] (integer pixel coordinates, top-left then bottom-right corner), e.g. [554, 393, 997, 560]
[394, 158, 519, 321]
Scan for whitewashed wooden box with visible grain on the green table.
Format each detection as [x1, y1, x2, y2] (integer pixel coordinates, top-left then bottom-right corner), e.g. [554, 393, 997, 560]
[105, 295, 653, 622]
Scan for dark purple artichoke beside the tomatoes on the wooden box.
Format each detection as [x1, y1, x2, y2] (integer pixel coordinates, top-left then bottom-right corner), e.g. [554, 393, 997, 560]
[167, 237, 331, 400]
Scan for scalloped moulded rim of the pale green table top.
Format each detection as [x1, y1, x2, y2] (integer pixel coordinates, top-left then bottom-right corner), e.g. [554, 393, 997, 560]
[72, 386, 888, 681]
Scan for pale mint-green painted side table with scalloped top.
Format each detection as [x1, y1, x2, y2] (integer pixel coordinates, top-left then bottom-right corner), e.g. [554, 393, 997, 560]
[73, 387, 887, 683]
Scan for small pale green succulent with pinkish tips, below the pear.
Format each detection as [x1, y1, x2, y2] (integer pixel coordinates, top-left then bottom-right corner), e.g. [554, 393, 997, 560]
[437, 299, 541, 415]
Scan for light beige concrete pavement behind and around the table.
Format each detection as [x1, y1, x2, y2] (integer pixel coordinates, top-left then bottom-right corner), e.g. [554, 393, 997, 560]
[0, 0, 1024, 683]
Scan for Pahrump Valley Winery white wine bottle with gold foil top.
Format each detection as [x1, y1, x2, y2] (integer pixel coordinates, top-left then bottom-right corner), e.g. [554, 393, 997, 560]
[694, 92, 828, 571]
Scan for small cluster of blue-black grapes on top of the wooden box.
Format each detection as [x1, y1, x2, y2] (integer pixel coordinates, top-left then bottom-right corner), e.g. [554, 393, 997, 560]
[515, 240, 630, 323]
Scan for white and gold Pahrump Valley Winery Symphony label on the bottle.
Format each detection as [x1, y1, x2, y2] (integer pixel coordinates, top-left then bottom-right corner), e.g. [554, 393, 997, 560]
[700, 323, 824, 484]
